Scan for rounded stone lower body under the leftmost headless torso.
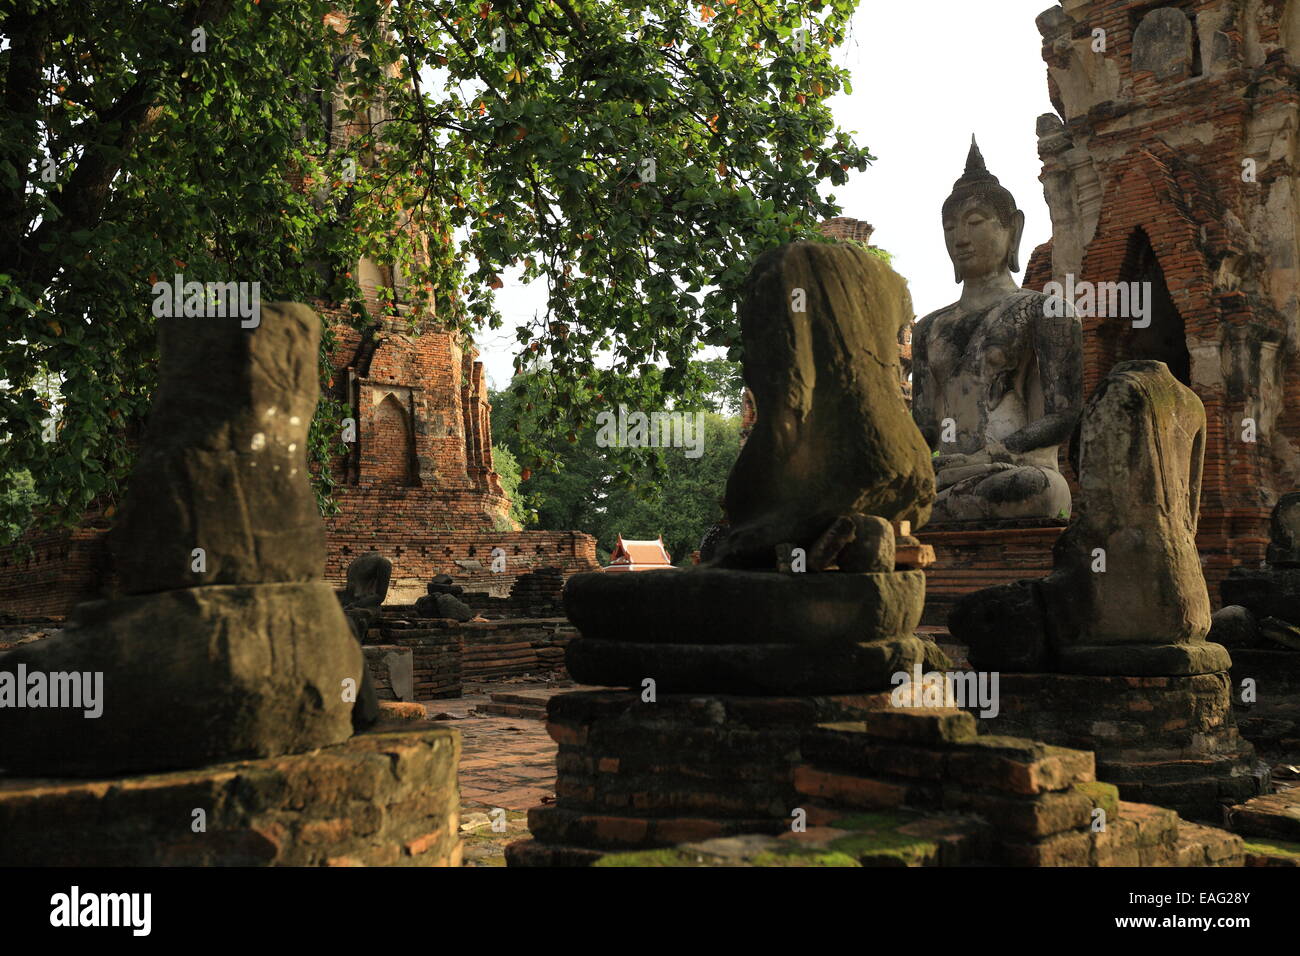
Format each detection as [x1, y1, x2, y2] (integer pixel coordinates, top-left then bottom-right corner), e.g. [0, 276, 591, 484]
[0, 581, 365, 777]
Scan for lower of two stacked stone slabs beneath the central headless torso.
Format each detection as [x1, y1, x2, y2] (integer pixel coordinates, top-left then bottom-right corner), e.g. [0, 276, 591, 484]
[566, 636, 926, 695]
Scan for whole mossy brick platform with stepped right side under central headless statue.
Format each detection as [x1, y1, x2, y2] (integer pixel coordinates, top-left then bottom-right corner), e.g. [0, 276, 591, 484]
[507, 692, 1245, 866]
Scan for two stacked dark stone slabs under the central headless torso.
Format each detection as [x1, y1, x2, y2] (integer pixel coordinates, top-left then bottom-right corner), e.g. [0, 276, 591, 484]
[564, 568, 926, 695]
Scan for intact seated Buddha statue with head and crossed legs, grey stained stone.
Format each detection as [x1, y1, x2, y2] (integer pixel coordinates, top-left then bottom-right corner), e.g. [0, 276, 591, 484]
[913, 138, 1083, 523]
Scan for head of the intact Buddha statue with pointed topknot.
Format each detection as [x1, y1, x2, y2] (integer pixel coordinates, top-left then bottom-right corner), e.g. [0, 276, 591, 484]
[943, 137, 1024, 282]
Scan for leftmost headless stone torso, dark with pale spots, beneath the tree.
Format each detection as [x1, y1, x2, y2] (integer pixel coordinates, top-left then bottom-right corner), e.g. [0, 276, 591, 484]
[111, 303, 325, 594]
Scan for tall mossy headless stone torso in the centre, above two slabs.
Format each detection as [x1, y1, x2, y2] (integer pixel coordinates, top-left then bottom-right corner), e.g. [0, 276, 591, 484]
[715, 242, 933, 567]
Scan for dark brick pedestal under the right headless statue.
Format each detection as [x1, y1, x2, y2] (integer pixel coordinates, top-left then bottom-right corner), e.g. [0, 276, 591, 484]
[984, 671, 1268, 822]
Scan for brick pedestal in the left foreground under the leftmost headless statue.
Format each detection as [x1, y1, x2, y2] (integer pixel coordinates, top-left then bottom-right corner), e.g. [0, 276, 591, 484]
[0, 728, 462, 866]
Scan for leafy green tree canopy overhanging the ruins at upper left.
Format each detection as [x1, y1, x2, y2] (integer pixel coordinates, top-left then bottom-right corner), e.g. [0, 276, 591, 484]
[0, 0, 871, 538]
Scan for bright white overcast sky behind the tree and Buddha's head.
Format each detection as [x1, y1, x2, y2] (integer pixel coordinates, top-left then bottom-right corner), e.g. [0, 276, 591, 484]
[477, 0, 1054, 388]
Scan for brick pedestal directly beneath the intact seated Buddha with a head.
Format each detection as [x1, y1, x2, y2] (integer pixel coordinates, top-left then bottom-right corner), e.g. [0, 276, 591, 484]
[917, 519, 1066, 626]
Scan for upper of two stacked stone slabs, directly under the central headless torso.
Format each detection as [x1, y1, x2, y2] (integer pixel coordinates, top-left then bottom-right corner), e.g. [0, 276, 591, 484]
[564, 567, 926, 645]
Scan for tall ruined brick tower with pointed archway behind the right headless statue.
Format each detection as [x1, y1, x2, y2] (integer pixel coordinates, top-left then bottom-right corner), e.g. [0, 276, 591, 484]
[1026, 0, 1300, 597]
